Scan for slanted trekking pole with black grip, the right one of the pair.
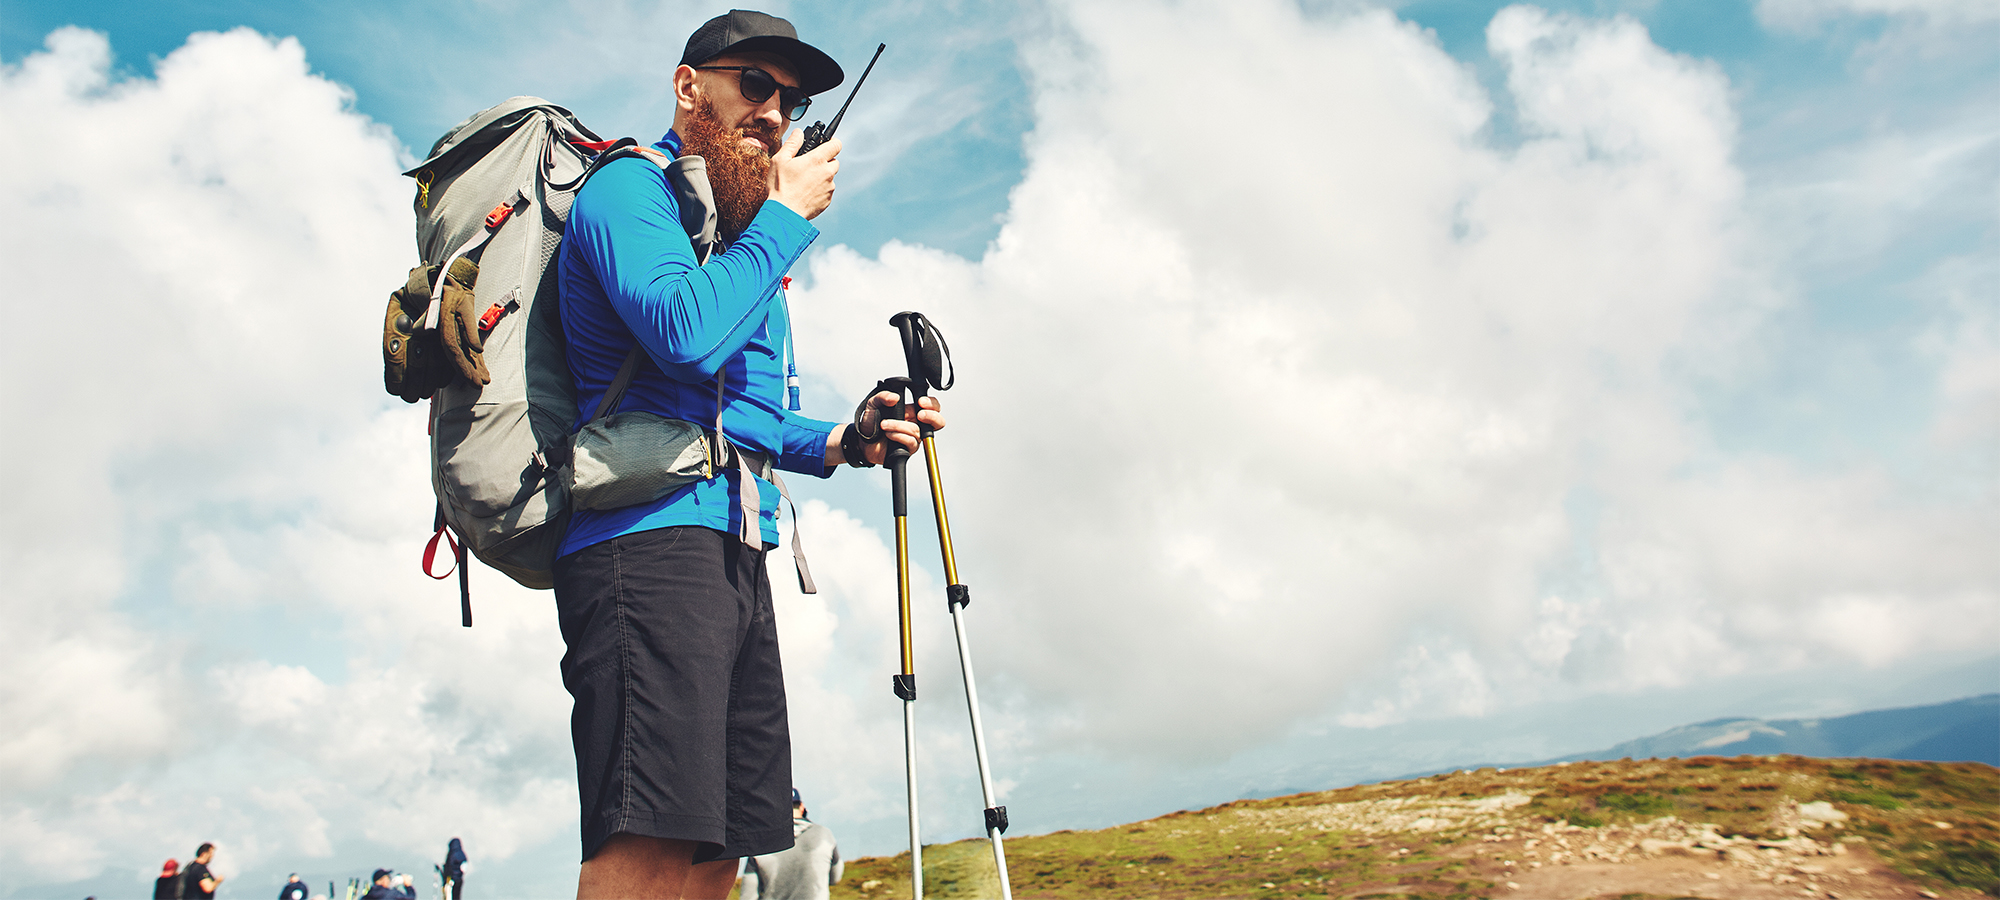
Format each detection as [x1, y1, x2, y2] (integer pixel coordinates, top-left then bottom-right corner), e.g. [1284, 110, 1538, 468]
[888, 310, 1014, 900]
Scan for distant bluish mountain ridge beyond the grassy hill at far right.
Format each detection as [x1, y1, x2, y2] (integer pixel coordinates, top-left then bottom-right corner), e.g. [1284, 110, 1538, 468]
[1548, 694, 2000, 766]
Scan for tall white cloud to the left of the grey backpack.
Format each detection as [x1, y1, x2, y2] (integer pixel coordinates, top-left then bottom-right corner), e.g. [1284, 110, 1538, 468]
[0, 28, 574, 886]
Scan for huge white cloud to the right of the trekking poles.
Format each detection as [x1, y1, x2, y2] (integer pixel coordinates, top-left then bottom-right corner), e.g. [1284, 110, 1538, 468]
[794, 4, 2000, 758]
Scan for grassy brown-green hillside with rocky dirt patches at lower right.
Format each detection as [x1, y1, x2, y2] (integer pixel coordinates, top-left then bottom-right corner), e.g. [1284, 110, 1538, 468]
[834, 756, 2000, 900]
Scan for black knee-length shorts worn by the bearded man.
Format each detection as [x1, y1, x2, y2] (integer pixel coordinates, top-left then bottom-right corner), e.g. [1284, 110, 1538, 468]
[556, 526, 792, 862]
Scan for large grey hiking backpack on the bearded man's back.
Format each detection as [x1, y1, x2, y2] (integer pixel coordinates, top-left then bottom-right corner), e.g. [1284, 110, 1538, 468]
[382, 96, 716, 626]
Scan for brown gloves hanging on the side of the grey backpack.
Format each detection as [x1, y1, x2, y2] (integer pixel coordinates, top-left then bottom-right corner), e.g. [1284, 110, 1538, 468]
[382, 258, 492, 404]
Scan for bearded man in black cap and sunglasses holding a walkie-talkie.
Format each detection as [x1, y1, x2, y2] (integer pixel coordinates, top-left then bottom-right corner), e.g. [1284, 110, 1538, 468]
[556, 10, 944, 898]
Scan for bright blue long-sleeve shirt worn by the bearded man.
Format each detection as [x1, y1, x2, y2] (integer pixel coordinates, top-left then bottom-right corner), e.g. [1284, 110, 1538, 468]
[556, 132, 834, 556]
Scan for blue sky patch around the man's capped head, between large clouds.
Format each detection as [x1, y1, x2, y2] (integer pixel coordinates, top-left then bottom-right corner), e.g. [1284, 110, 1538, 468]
[11, 2, 1038, 262]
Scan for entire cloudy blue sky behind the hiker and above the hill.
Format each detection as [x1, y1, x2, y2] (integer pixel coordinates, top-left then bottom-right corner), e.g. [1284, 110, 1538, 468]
[0, 0, 2000, 896]
